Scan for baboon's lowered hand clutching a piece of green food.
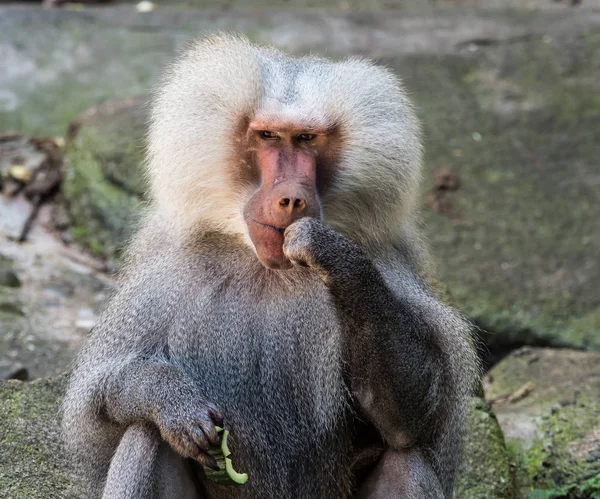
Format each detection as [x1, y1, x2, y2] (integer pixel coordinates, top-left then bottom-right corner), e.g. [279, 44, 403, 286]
[156, 398, 223, 470]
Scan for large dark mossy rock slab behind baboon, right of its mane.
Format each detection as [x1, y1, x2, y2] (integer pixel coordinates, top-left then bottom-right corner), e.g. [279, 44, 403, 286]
[390, 24, 600, 350]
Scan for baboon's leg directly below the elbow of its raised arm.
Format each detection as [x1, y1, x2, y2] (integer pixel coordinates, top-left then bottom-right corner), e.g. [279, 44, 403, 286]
[357, 449, 444, 499]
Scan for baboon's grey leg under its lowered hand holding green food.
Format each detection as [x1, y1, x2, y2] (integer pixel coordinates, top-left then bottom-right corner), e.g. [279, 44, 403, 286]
[102, 425, 204, 499]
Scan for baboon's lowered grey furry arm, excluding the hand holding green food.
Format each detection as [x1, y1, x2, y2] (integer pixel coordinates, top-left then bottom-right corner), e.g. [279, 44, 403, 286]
[65, 254, 193, 425]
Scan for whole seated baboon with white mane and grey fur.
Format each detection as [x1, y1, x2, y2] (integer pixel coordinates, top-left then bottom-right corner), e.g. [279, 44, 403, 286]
[63, 34, 478, 499]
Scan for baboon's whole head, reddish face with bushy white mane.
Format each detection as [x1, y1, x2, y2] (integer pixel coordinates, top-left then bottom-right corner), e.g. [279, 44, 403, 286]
[146, 36, 421, 270]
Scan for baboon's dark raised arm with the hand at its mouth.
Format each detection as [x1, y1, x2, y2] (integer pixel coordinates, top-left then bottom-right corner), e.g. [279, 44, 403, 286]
[287, 219, 453, 449]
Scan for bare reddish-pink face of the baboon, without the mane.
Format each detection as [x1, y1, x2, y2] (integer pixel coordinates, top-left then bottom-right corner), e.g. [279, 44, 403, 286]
[243, 116, 340, 269]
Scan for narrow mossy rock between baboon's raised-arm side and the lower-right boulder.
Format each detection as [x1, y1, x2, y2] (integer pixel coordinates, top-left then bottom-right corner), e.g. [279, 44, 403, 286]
[454, 398, 515, 499]
